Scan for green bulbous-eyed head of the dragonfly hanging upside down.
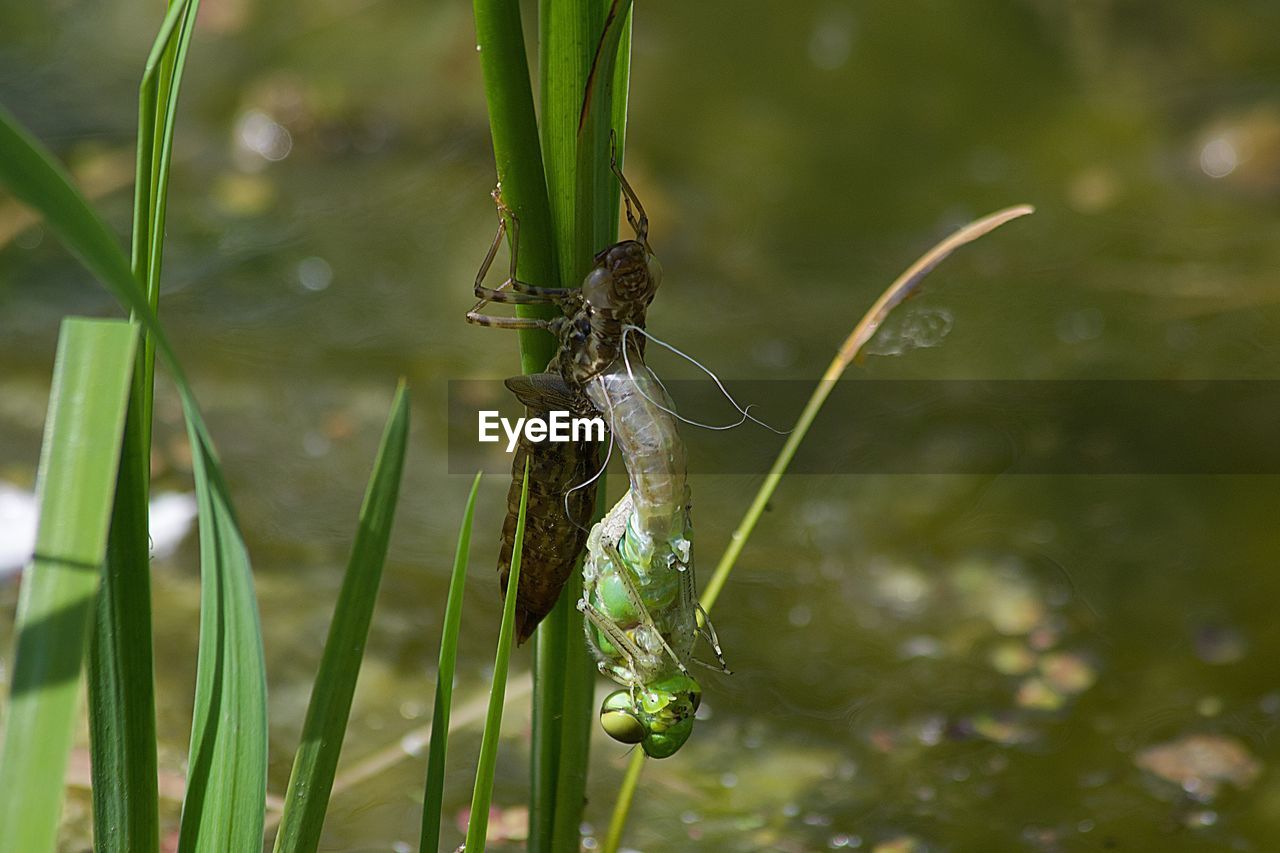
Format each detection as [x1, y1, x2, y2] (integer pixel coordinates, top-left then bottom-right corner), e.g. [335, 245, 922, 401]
[600, 674, 703, 758]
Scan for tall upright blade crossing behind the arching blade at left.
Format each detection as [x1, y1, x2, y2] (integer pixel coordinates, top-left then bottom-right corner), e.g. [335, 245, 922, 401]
[88, 0, 196, 853]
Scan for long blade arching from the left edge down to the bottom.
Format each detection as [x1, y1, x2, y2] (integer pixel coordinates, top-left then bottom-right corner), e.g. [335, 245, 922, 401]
[0, 87, 266, 850]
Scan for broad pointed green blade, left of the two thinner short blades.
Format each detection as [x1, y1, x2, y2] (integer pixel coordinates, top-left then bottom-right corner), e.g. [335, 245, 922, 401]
[275, 383, 408, 853]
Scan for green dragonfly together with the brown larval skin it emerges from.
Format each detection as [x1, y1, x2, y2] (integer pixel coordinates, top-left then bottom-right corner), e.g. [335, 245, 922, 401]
[467, 144, 728, 758]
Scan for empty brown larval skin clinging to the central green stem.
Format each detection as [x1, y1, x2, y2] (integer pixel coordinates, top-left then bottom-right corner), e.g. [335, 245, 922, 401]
[466, 144, 662, 643]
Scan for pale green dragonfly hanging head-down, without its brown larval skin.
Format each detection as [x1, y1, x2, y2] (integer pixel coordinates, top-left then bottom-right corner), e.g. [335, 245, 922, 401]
[577, 353, 728, 758]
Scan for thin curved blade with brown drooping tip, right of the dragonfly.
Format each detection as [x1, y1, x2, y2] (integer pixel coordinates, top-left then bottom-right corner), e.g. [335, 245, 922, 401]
[602, 205, 1034, 853]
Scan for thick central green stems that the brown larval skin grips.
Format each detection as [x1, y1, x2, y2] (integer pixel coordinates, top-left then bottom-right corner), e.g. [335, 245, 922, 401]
[475, 0, 631, 850]
